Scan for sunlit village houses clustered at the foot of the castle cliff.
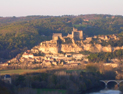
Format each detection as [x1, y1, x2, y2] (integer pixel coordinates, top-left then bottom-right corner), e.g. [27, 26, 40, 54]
[0, 47, 88, 68]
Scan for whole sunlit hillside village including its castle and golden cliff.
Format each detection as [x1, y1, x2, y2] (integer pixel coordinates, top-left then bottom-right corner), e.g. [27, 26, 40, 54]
[0, 28, 123, 69]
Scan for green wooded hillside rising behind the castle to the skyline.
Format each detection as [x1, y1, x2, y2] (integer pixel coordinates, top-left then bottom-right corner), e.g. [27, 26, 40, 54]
[0, 14, 123, 59]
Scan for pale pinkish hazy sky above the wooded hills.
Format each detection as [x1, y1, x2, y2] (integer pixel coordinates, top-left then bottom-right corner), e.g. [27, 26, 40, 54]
[0, 0, 123, 17]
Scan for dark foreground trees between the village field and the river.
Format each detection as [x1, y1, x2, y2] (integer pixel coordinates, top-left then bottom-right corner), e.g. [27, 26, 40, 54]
[0, 63, 123, 94]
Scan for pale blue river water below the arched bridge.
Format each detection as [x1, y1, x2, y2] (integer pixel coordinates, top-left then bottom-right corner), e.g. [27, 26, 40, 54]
[87, 90, 121, 94]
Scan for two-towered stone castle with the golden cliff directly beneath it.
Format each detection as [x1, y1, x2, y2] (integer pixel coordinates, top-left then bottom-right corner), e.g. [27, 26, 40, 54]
[32, 28, 83, 54]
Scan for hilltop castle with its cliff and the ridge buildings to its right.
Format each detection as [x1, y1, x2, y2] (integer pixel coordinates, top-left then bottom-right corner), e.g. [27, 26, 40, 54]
[31, 28, 123, 54]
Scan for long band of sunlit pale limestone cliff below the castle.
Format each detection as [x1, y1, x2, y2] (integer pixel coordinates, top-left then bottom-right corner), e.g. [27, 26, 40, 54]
[32, 43, 123, 54]
